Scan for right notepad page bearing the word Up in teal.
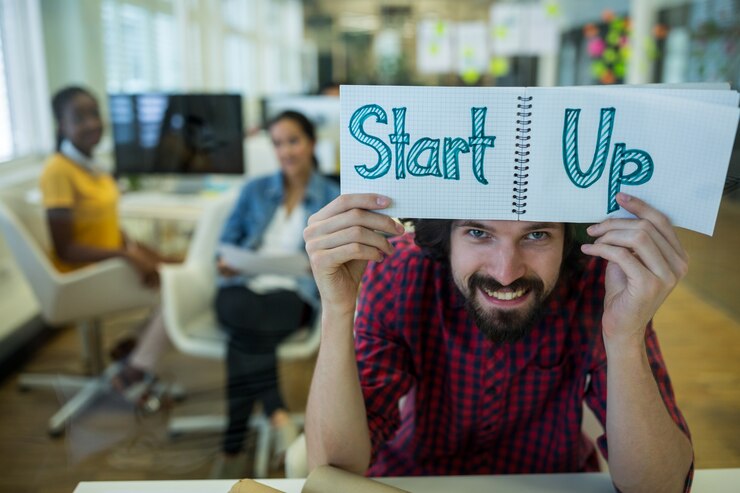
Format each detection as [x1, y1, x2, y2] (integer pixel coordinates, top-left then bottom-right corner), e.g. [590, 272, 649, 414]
[522, 88, 738, 234]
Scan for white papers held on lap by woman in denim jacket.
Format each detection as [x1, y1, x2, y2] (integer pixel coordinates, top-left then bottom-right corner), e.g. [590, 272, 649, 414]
[218, 244, 311, 276]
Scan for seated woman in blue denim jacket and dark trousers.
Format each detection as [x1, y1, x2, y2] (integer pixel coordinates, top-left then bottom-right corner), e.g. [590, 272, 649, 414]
[212, 111, 339, 477]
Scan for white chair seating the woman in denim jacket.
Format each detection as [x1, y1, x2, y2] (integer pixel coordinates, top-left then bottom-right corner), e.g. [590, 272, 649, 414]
[161, 195, 321, 477]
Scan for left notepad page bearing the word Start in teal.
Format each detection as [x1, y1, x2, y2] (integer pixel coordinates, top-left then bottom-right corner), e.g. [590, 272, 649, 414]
[340, 86, 521, 219]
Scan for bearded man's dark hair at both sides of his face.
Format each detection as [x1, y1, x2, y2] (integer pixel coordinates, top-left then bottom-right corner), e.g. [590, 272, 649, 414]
[402, 219, 582, 272]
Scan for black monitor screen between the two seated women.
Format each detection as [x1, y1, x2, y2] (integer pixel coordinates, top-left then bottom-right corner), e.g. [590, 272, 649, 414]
[109, 93, 245, 175]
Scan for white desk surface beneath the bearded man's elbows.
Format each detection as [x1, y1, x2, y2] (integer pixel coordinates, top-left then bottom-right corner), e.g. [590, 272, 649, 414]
[74, 469, 740, 493]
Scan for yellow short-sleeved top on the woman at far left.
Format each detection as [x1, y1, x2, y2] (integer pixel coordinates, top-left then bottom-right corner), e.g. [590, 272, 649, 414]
[40, 153, 123, 272]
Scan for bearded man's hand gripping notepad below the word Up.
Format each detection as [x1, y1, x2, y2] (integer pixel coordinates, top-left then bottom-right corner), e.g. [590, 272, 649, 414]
[581, 193, 689, 344]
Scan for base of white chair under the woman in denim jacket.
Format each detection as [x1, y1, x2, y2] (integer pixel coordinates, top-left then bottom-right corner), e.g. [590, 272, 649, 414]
[167, 413, 305, 478]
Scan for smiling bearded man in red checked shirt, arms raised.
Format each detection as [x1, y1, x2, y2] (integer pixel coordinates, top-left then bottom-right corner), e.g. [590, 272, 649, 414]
[304, 193, 693, 491]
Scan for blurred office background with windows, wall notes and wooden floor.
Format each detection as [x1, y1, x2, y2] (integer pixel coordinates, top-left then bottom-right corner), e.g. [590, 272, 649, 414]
[0, 0, 740, 492]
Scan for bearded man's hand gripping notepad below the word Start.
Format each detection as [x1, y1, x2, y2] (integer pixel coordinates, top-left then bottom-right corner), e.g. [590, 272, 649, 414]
[303, 194, 404, 314]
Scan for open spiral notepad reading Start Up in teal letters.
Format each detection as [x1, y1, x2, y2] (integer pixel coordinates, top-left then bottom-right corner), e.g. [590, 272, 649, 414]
[340, 84, 738, 234]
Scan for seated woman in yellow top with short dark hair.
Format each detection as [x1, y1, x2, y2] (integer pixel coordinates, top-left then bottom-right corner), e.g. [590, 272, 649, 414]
[40, 87, 173, 400]
